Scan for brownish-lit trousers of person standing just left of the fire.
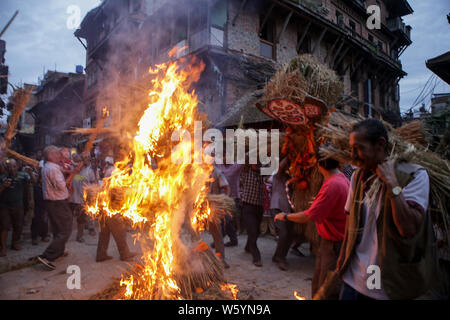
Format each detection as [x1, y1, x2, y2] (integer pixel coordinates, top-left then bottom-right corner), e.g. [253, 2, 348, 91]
[97, 216, 130, 260]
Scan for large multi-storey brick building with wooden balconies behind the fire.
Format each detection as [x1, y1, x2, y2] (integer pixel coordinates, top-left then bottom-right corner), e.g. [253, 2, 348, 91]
[75, 0, 413, 127]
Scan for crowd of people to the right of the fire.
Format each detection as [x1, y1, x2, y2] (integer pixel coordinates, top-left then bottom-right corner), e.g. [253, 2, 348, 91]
[206, 119, 449, 300]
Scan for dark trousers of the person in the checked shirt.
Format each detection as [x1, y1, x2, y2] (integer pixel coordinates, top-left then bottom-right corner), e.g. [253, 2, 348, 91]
[242, 202, 263, 262]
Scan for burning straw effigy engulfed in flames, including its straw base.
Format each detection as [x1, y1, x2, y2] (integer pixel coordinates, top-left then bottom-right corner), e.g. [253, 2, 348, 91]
[85, 52, 237, 299]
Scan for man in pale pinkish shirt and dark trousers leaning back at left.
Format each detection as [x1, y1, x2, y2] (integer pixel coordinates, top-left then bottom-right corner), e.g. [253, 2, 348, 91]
[38, 146, 73, 270]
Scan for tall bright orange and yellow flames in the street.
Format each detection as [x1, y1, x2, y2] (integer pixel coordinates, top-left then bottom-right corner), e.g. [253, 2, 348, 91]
[85, 52, 219, 299]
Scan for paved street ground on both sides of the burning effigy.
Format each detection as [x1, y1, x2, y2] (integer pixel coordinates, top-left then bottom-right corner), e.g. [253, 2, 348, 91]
[0, 221, 314, 300]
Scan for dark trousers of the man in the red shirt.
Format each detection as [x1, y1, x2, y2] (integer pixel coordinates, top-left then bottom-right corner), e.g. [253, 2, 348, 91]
[311, 237, 342, 299]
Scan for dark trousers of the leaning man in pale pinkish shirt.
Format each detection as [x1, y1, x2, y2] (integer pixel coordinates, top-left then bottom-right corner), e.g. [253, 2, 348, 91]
[42, 200, 73, 261]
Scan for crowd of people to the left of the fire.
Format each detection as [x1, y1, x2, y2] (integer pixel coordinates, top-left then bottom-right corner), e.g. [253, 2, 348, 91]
[0, 146, 136, 270]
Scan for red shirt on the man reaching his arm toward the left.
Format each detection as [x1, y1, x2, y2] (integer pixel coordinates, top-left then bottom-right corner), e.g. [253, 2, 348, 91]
[305, 173, 350, 241]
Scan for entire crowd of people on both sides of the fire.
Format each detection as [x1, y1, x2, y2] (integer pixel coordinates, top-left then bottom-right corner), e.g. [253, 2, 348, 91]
[0, 119, 449, 300]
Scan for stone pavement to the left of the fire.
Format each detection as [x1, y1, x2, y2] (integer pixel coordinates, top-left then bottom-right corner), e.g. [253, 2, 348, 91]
[0, 222, 140, 300]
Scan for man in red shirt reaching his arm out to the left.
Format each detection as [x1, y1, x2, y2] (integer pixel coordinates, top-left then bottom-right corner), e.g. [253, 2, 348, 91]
[275, 158, 350, 296]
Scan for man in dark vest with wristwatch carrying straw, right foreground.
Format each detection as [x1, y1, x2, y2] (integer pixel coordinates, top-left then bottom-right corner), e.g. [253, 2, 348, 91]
[314, 119, 437, 300]
